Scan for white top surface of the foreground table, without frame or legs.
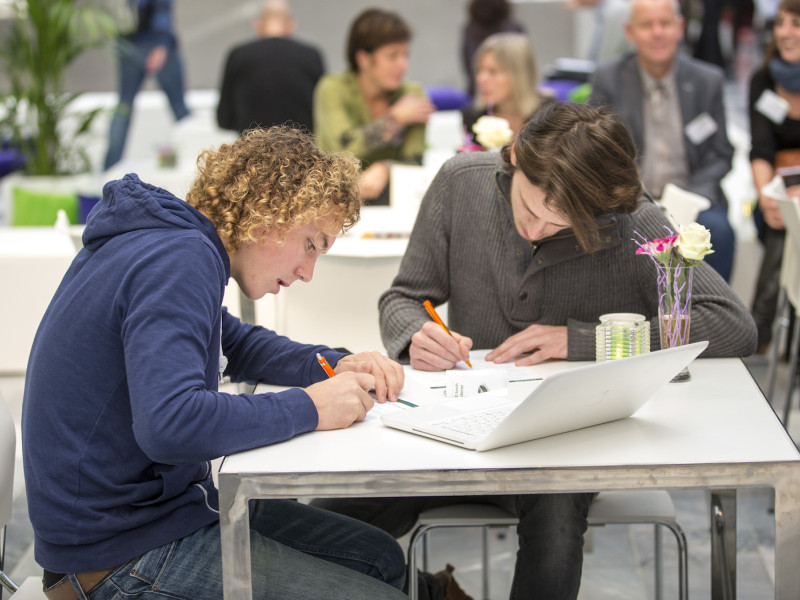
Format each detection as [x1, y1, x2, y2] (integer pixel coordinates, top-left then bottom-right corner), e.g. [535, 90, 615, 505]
[220, 359, 800, 474]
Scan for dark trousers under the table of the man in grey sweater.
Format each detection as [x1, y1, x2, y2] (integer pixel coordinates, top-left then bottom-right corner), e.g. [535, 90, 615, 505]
[311, 494, 595, 600]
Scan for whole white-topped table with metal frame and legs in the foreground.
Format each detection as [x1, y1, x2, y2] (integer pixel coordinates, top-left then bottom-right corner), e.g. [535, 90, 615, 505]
[219, 359, 800, 600]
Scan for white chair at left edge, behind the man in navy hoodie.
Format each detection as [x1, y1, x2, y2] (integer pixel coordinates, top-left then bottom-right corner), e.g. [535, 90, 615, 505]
[0, 394, 46, 600]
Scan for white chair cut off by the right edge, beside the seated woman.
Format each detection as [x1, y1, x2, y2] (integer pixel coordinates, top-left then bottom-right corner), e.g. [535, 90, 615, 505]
[762, 176, 800, 428]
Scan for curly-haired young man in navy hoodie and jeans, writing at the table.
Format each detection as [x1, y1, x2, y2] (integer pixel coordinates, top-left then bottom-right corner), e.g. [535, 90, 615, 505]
[22, 127, 405, 600]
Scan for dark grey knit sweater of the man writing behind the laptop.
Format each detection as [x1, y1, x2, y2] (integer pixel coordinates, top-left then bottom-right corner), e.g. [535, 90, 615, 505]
[379, 152, 756, 361]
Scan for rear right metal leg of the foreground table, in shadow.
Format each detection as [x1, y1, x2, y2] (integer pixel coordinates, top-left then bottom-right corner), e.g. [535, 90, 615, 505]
[711, 489, 736, 600]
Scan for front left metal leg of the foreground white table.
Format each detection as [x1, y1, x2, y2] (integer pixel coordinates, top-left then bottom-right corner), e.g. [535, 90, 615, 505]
[219, 477, 253, 600]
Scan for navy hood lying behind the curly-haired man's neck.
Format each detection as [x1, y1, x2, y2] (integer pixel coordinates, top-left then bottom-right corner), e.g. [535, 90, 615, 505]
[83, 173, 230, 271]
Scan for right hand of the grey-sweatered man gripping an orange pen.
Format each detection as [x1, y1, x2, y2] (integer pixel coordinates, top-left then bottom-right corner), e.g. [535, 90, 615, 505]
[409, 301, 472, 371]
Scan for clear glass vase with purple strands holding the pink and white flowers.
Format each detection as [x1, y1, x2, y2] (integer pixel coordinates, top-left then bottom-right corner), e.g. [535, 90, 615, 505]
[658, 264, 694, 382]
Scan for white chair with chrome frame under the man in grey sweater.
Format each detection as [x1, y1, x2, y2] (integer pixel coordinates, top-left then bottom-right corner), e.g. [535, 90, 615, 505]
[408, 490, 689, 600]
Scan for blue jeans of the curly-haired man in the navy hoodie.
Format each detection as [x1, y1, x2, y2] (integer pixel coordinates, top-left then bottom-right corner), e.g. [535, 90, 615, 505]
[51, 500, 408, 600]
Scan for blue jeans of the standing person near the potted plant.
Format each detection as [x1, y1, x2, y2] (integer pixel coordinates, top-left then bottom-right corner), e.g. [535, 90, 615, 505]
[103, 39, 189, 170]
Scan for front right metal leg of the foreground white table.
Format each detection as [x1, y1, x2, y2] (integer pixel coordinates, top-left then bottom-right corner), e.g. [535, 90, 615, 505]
[775, 476, 800, 600]
